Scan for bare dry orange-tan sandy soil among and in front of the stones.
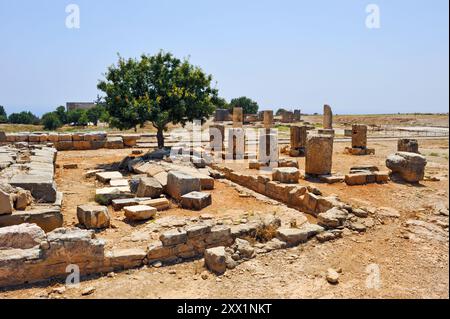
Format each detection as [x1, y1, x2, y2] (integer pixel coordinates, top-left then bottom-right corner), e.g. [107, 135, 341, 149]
[0, 135, 449, 298]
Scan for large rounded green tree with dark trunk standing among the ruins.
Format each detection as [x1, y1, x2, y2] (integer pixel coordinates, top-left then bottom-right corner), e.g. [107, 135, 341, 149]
[98, 51, 218, 148]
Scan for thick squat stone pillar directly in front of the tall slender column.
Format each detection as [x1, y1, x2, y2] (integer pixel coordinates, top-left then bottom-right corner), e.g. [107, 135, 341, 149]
[305, 135, 334, 176]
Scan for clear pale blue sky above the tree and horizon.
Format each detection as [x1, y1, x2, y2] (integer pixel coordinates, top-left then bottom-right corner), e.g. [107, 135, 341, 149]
[0, 0, 449, 114]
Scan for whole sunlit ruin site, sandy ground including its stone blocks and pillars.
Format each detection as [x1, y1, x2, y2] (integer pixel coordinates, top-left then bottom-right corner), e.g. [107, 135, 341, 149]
[0, 110, 449, 298]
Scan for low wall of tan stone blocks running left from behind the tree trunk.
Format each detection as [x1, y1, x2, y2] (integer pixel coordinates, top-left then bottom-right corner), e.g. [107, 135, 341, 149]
[0, 132, 140, 151]
